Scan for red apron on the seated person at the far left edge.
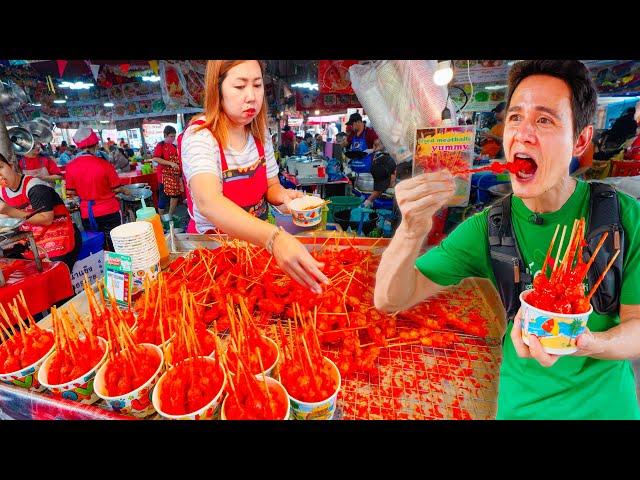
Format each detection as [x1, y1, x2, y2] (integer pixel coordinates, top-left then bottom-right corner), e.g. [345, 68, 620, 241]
[0, 176, 75, 259]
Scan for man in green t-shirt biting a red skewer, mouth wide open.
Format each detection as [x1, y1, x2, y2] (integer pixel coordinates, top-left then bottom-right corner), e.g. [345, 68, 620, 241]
[375, 60, 640, 419]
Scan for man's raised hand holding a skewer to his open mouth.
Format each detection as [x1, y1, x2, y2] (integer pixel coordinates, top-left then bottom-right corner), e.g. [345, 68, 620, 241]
[395, 170, 456, 237]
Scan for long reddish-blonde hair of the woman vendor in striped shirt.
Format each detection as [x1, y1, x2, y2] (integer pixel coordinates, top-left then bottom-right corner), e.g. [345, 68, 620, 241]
[196, 60, 267, 148]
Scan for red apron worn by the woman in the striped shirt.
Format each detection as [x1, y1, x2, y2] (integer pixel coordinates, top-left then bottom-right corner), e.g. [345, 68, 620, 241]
[178, 120, 269, 233]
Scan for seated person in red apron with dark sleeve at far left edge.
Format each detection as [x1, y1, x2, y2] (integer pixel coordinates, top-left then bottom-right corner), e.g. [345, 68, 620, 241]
[0, 154, 82, 272]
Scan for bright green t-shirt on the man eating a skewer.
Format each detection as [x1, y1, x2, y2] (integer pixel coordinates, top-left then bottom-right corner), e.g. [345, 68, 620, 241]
[416, 181, 640, 419]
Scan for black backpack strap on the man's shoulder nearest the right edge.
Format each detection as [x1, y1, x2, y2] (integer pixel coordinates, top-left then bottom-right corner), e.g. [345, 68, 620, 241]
[583, 182, 624, 314]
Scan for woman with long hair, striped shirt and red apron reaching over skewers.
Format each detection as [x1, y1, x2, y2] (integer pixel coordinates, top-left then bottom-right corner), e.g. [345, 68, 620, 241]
[178, 60, 329, 293]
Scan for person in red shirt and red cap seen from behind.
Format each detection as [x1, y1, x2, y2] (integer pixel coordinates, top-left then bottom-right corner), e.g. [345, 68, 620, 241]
[65, 127, 128, 251]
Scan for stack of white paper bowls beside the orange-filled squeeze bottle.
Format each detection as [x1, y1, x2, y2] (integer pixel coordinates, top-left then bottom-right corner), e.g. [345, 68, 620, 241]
[111, 222, 160, 294]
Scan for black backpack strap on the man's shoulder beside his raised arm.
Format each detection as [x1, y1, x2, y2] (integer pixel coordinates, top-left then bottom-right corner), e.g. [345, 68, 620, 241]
[487, 195, 531, 320]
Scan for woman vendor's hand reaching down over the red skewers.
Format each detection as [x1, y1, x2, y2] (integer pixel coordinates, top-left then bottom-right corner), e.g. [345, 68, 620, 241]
[273, 231, 329, 294]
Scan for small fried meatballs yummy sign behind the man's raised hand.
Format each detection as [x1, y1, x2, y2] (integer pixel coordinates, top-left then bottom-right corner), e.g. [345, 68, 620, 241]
[413, 125, 476, 207]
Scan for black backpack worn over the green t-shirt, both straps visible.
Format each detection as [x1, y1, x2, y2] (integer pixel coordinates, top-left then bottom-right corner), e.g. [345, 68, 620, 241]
[487, 182, 624, 321]
